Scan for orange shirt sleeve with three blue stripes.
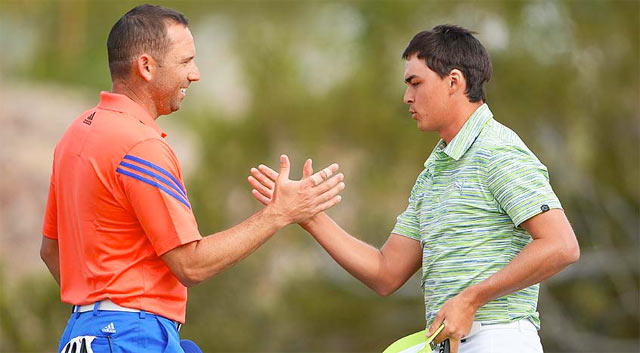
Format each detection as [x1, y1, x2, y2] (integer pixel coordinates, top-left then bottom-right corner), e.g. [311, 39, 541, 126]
[116, 139, 202, 256]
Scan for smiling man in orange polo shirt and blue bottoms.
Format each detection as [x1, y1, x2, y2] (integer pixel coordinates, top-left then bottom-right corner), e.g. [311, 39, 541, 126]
[41, 5, 344, 353]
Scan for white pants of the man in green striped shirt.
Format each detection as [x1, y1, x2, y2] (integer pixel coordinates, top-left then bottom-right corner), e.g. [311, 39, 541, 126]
[433, 320, 543, 353]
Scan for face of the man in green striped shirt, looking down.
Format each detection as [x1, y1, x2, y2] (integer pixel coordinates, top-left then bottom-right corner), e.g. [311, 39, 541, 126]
[403, 55, 451, 131]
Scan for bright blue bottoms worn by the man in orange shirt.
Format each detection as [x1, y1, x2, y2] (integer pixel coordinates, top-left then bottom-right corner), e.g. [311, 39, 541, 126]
[58, 304, 184, 353]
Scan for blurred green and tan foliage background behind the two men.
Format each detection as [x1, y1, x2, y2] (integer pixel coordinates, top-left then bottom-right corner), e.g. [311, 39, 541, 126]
[0, 0, 640, 352]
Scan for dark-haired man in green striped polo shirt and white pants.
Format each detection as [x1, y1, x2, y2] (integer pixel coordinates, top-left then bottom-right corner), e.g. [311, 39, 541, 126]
[249, 25, 579, 353]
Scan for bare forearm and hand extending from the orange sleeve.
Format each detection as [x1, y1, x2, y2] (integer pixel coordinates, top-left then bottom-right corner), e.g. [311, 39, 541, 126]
[163, 155, 344, 286]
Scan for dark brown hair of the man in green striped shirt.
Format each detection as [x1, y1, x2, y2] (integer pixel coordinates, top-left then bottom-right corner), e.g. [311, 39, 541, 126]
[402, 25, 491, 102]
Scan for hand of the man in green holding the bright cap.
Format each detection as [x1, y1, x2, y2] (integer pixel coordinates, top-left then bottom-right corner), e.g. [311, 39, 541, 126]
[427, 291, 478, 353]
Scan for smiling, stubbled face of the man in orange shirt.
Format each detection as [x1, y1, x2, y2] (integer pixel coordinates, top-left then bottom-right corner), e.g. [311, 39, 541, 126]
[150, 23, 200, 115]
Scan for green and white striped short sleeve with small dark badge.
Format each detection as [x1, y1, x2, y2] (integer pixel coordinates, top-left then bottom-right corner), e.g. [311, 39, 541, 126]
[487, 145, 562, 227]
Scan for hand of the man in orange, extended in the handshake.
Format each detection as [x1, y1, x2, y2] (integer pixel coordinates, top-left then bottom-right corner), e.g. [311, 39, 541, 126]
[264, 154, 345, 224]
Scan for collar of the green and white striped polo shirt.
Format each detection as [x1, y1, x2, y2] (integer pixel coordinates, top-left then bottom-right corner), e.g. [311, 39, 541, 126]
[435, 103, 493, 161]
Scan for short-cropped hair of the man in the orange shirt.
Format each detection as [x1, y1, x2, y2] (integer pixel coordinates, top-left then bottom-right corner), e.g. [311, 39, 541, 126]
[107, 5, 189, 79]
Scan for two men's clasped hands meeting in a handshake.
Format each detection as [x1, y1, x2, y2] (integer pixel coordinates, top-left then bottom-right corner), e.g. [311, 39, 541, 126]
[248, 154, 345, 225]
